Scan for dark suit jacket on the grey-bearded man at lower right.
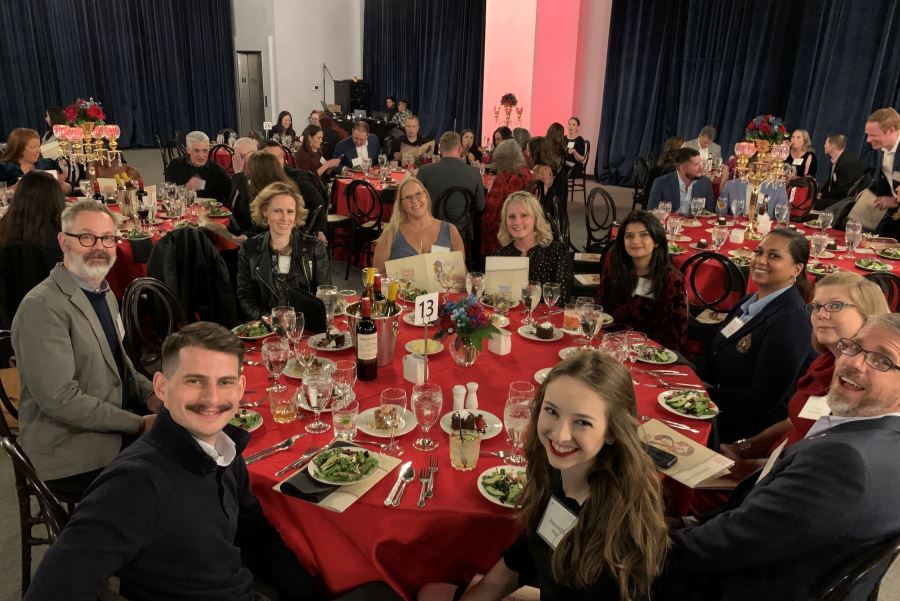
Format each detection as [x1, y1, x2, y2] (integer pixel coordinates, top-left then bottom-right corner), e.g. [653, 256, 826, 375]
[656, 416, 900, 601]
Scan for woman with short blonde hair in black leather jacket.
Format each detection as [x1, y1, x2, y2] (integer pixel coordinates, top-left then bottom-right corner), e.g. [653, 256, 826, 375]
[237, 181, 331, 332]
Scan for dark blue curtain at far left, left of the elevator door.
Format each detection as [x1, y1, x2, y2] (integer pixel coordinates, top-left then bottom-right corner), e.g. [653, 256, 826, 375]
[0, 0, 237, 147]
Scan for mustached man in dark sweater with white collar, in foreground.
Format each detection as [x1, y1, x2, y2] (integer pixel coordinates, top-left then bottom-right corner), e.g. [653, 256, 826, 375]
[26, 322, 400, 601]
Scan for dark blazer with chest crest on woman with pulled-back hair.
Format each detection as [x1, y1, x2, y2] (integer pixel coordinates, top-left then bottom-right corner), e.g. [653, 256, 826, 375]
[697, 287, 814, 442]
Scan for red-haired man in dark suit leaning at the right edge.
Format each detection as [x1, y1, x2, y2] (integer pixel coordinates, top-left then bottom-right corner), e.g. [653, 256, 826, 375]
[866, 107, 900, 238]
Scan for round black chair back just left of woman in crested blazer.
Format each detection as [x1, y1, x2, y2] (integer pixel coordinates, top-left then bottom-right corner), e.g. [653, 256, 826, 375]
[681, 251, 747, 312]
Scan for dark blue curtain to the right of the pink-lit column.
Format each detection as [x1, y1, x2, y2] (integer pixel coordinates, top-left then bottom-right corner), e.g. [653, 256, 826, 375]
[595, 0, 900, 184]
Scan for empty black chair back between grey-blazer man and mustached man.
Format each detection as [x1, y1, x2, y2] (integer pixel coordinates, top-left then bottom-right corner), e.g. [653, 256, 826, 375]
[122, 277, 186, 378]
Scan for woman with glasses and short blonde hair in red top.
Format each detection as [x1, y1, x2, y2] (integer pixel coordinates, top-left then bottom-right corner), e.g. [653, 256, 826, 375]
[721, 271, 891, 474]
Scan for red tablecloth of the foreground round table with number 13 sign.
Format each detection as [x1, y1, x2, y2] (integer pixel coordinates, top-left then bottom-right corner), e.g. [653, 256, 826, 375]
[245, 307, 710, 599]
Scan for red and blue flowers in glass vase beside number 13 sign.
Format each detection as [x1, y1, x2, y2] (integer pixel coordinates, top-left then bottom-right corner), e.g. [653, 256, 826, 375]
[434, 295, 500, 367]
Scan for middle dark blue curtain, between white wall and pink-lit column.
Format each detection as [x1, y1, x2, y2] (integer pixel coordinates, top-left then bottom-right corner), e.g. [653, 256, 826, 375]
[363, 0, 485, 137]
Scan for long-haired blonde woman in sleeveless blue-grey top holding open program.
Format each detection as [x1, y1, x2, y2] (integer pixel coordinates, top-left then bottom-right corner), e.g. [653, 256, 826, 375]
[372, 177, 466, 273]
